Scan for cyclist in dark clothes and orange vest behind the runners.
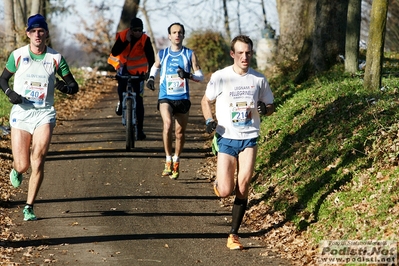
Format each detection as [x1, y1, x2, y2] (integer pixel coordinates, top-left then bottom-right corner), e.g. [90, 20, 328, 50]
[108, 18, 155, 140]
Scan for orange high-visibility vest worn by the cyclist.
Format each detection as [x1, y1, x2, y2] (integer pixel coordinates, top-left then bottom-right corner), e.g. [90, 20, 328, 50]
[107, 29, 148, 75]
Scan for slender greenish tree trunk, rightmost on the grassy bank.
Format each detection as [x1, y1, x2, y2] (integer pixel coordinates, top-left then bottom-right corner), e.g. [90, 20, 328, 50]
[363, 0, 388, 90]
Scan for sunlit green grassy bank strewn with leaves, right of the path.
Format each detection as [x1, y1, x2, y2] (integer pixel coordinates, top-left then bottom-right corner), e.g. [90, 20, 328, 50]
[253, 61, 399, 243]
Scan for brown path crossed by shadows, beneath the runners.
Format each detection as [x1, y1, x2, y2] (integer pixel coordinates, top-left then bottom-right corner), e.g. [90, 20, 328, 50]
[6, 80, 289, 266]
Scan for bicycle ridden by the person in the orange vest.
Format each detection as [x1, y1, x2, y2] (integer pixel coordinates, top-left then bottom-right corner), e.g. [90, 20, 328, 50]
[107, 74, 145, 151]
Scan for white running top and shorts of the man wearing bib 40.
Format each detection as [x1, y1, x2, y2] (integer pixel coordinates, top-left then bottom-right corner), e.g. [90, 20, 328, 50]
[6, 45, 70, 134]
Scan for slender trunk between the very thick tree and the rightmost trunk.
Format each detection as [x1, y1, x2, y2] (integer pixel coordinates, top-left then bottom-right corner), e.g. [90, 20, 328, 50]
[345, 0, 362, 73]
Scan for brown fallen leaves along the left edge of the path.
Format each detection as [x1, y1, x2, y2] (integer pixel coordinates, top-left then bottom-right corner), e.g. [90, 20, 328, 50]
[0, 72, 122, 266]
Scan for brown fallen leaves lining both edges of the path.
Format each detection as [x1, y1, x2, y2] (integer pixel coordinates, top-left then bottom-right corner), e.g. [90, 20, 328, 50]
[0, 70, 315, 265]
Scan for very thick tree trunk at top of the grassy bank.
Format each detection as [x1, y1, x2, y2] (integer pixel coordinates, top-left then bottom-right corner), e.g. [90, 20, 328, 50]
[276, 0, 349, 83]
